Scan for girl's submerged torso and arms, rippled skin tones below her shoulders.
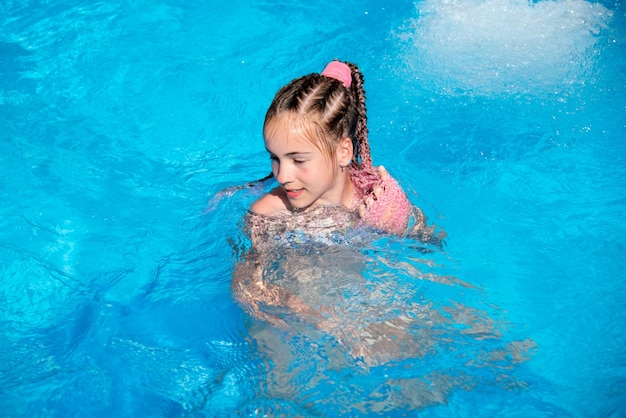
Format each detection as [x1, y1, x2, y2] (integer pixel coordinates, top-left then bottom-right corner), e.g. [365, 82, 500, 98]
[233, 206, 454, 367]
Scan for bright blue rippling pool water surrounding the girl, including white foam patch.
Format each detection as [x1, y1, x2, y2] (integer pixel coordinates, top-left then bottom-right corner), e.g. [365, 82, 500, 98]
[0, 0, 626, 417]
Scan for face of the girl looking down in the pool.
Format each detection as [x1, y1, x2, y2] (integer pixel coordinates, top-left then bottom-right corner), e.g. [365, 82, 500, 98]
[265, 116, 345, 209]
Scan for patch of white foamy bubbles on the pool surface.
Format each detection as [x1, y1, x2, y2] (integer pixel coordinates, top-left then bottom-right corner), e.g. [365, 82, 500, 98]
[401, 0, 612, 94]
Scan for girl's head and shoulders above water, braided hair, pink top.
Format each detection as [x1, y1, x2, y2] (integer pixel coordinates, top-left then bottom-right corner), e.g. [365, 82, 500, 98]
[245, 61, 439, 242]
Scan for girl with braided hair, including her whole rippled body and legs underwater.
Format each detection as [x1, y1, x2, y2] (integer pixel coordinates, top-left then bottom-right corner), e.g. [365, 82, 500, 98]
[227, 61, 525, 402]
